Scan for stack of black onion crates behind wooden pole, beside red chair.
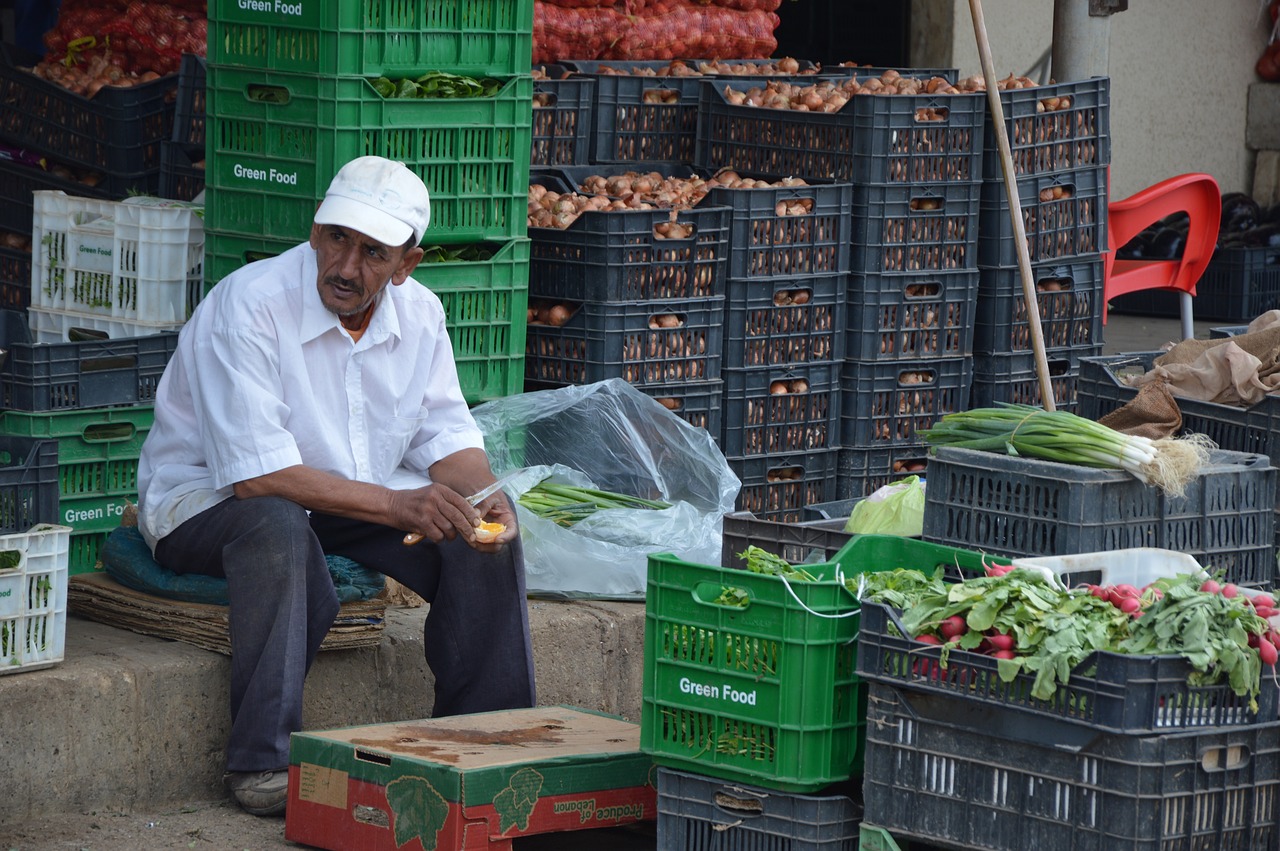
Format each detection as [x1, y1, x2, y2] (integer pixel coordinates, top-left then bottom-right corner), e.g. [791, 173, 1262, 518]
[972, 77, 1111, 411]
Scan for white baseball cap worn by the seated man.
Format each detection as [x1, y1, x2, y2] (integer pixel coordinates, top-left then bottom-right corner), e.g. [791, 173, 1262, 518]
[315, 156, 431, 246]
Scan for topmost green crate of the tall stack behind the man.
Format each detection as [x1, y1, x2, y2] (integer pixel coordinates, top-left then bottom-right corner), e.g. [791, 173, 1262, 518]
[209, 0, 534, 77]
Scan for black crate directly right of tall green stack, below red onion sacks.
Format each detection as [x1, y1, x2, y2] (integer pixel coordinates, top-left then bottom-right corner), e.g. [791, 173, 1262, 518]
[529, 64, 595, 165]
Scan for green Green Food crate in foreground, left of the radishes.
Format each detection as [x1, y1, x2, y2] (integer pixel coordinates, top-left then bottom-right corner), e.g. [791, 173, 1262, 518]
[640, 535, 982, 792]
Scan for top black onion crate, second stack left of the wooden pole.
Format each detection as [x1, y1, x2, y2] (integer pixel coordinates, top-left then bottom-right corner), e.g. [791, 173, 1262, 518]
[703, 171, 856, 280]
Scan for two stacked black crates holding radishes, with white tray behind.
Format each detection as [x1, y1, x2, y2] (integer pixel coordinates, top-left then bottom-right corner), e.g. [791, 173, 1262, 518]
[856, 549, 1280, 851]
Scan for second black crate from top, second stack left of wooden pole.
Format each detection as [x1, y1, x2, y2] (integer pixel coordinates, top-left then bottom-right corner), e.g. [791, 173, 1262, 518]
[724, 275, 847, 370]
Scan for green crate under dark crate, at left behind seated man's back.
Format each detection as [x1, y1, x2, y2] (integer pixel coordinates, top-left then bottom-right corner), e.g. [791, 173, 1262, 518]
[0, 404, 155, 576]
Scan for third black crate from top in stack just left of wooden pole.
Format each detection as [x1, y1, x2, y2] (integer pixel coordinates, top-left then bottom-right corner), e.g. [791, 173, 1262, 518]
[845, 270, 979, 362]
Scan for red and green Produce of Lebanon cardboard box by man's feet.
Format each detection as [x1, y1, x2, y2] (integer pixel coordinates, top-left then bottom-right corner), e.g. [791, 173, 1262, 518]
[284, 706, 658, 851]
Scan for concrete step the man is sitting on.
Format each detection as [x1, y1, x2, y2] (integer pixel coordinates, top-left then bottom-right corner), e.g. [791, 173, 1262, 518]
[0, 600, 644, 824]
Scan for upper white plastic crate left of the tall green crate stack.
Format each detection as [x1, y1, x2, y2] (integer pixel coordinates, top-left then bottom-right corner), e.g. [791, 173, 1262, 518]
[31, 189, 205, 324]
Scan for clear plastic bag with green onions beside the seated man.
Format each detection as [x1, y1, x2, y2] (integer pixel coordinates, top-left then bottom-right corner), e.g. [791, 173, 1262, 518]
[472, 379, 741, 600]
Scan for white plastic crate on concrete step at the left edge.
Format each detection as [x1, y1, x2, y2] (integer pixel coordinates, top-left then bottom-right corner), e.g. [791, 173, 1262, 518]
[0, 523, 72, 674]
